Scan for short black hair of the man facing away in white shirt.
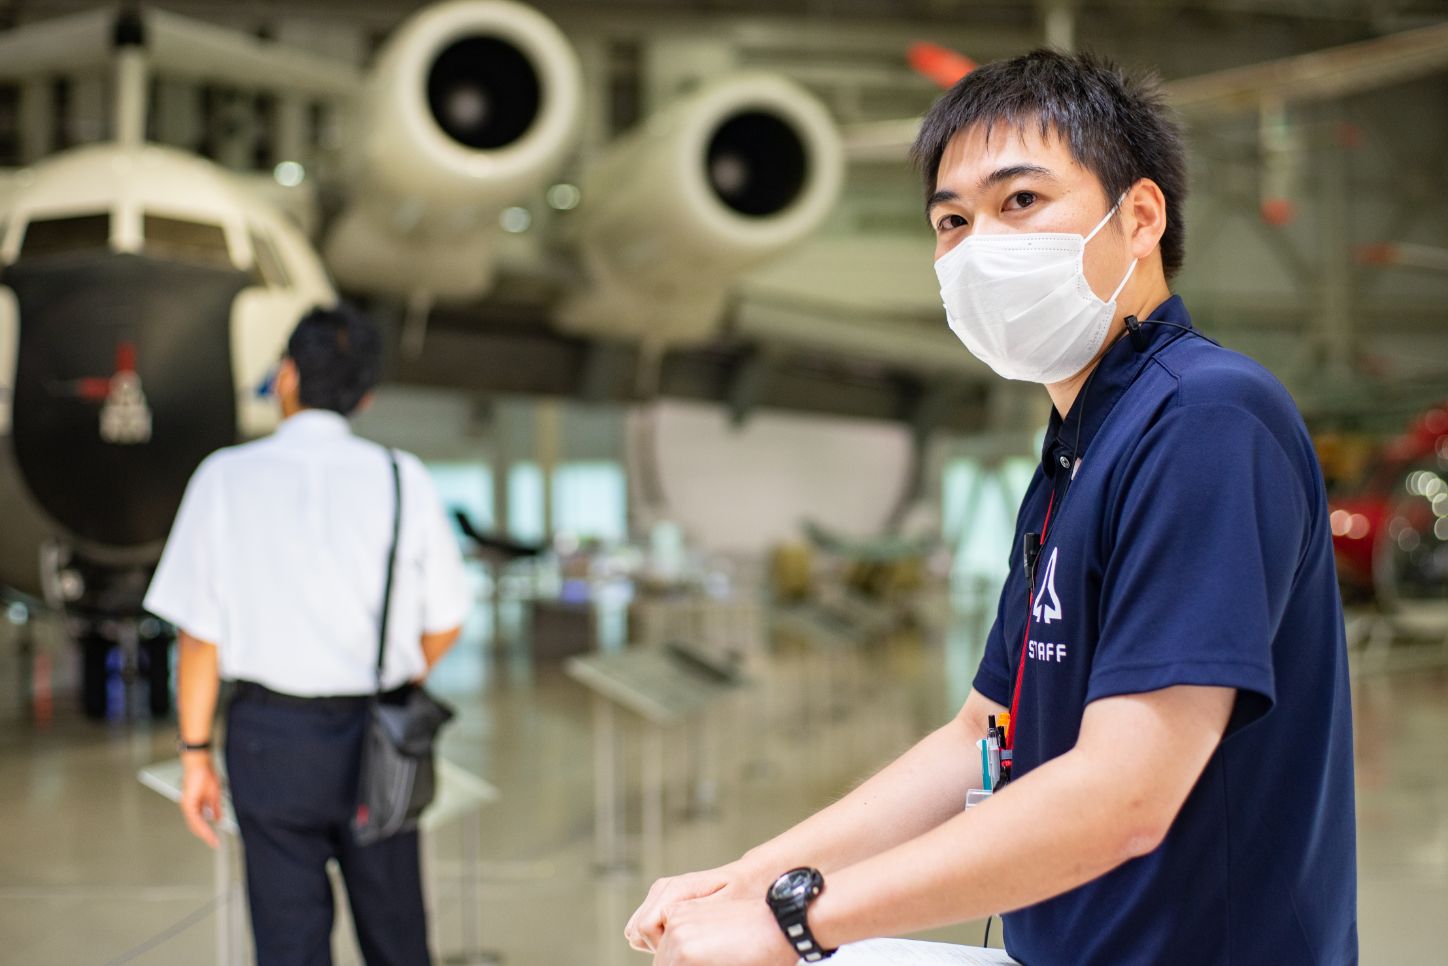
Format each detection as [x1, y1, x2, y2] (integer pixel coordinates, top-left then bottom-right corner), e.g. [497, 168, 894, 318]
[287, 303, 382, 416]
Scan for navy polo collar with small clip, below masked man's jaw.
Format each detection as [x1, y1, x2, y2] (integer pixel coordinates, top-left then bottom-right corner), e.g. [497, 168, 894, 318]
[1041, 295, 1192, 478]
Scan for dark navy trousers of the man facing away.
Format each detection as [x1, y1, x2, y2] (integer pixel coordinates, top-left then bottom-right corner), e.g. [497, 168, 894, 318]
[226, 692, 432, 966]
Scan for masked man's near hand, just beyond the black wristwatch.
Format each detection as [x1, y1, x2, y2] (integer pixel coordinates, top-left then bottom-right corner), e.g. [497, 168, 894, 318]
[653, 895, 799, 966]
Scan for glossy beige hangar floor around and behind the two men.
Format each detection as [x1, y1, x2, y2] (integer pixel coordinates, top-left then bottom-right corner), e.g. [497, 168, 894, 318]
[0, 596, 1448, 966]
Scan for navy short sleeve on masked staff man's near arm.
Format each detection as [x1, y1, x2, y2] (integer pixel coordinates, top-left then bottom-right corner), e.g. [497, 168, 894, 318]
[1086, 404, 1310, 733]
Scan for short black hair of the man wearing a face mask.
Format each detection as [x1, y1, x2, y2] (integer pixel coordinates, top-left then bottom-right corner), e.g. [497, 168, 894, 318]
[911, 49, 1186, 278]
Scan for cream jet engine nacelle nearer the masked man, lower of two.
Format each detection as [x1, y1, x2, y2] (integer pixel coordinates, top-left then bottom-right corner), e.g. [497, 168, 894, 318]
[557, 74, 844, 346]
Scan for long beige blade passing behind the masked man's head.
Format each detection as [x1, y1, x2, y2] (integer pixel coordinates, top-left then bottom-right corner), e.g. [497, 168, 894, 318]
[844, 23, 1448, 161]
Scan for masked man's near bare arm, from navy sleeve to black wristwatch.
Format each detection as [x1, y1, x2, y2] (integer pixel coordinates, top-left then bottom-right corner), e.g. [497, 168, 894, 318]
[809, 686, 1235, 946]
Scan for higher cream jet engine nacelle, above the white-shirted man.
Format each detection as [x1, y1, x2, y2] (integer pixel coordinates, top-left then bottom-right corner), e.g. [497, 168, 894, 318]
[326, 0, 582, 298]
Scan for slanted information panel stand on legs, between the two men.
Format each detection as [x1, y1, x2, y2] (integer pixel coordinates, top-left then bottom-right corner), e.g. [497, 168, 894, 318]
[566, 644, 744, 875]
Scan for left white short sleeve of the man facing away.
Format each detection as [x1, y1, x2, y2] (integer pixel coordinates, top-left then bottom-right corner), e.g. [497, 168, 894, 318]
[145, 461, 226, 644]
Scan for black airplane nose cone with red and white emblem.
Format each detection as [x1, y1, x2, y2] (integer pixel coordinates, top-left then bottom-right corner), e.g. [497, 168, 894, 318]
[0, 252, 251, 547]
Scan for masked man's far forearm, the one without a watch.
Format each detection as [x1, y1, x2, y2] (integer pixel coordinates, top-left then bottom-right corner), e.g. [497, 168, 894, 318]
[741, 694, 996, 878]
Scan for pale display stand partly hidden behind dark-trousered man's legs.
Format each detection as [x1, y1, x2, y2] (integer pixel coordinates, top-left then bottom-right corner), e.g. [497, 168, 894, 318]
[136, 756, 502, 966]
